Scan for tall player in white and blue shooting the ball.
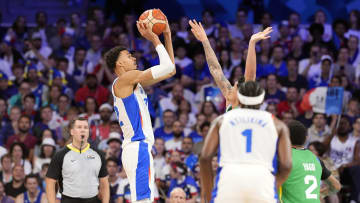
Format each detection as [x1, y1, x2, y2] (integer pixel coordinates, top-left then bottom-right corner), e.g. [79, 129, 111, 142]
[106, 13, 176, 202]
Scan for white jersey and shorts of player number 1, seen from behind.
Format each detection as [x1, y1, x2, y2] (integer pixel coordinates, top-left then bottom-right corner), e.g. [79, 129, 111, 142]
[212, 108, 278, 203]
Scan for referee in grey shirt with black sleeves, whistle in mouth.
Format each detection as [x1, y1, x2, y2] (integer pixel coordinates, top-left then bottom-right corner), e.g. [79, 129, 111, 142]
[46, 118, 110, 203]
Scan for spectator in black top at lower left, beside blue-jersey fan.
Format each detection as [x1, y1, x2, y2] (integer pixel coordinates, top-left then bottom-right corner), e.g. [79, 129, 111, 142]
[5, 165, 26, 200]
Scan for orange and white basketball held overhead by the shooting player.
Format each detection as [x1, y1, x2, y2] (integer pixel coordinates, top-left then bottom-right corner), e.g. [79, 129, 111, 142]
[139, 9, 166, 35]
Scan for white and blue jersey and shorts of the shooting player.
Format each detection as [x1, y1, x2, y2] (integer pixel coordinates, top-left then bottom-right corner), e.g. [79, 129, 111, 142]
[112, 78, 155, 202]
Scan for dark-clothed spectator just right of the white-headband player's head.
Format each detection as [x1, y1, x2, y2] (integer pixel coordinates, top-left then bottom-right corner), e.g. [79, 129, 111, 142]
[264, 74, 286, 104]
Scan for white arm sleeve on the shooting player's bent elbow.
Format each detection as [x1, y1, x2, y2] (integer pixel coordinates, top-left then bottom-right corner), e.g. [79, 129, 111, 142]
[151, 44, 175, 79]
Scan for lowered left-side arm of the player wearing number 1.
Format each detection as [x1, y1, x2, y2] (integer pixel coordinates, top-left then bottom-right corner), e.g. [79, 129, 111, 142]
[200, 116, 223, 202]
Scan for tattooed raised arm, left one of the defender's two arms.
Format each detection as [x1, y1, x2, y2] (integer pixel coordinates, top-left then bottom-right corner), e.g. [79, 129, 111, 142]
[189, 20, 232, 98]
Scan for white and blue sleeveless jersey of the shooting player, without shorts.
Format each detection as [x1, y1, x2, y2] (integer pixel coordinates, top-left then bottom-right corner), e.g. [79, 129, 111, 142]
[112, 78, 154, 147]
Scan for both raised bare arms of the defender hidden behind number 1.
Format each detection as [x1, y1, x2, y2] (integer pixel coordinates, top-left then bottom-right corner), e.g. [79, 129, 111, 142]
[189, 20, 272, 110]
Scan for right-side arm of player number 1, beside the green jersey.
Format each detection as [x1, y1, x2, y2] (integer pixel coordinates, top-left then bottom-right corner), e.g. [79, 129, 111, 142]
[274, 118, 292, 188]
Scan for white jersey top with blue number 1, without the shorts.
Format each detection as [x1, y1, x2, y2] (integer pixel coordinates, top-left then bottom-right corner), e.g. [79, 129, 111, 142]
[218, 108, 278, 172]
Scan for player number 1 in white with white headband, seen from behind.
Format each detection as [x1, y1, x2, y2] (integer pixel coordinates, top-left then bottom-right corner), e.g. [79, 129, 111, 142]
[200, 78, 291, 203]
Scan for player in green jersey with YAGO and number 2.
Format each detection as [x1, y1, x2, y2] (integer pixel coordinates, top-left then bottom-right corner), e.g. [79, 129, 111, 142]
[279, 120, 341, 203]
